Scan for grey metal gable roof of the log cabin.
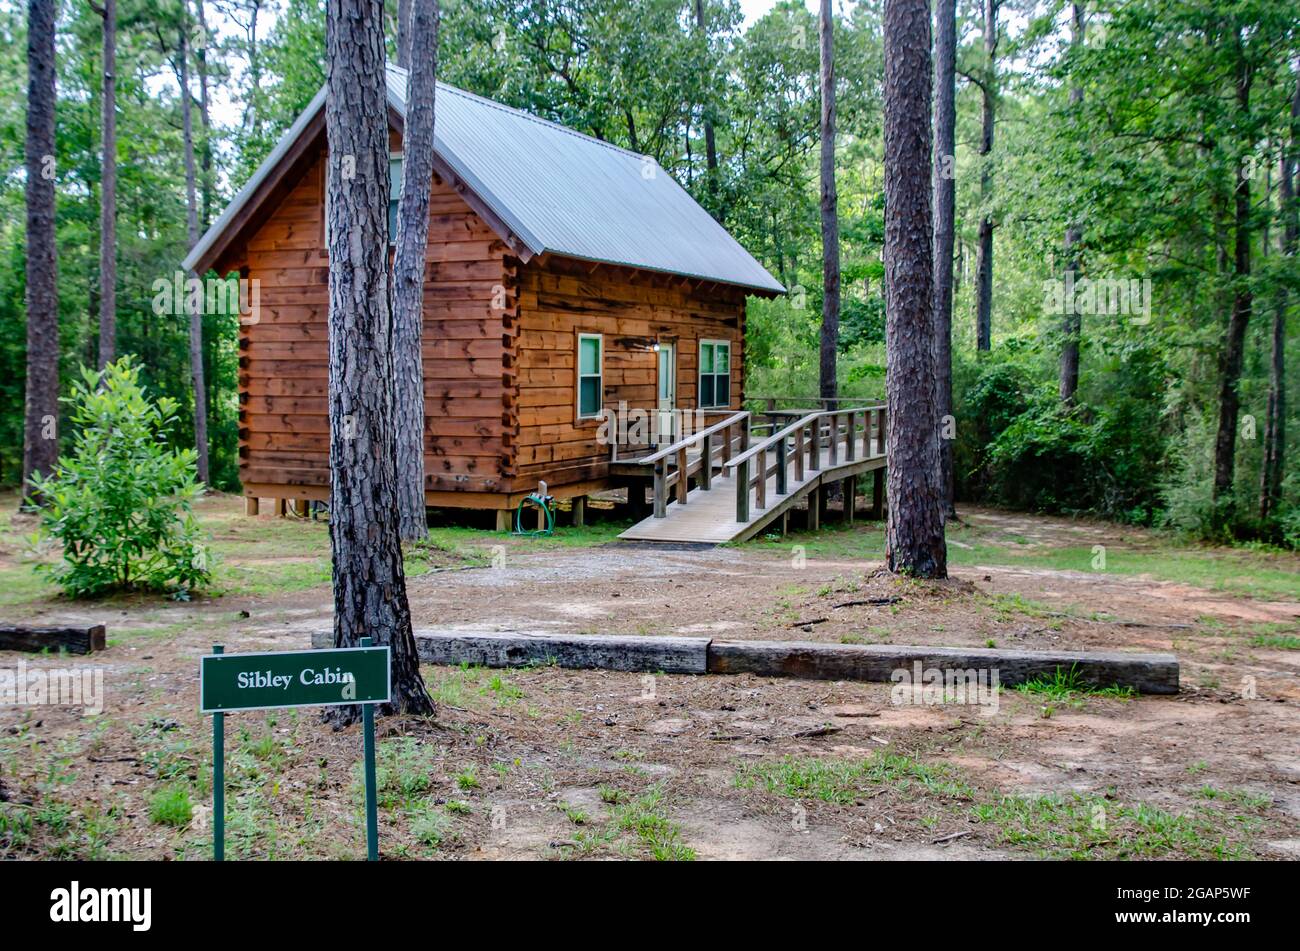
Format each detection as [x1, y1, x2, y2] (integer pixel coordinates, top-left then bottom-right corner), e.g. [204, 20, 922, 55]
[186, 65, 785, 294]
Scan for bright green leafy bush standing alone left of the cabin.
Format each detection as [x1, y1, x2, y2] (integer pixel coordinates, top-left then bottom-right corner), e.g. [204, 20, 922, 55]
[34, 357, 211, 598]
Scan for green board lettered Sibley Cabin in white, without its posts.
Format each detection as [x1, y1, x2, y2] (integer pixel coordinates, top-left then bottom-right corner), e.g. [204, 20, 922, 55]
[199, 647, 391, 713]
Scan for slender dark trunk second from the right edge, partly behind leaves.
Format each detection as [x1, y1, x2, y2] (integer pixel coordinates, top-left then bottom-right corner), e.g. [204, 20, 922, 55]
[1213, 42, 1253, 519]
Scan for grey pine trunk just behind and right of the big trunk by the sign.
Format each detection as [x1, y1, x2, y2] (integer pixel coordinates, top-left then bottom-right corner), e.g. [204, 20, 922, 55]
[393, 0, 438, 542]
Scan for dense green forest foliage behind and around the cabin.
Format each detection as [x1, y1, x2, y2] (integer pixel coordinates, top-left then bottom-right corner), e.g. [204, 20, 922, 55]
[0, 0, 1300, 547]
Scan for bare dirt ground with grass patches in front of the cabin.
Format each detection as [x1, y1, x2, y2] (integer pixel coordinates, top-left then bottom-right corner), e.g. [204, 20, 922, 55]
[0, 498, 1300, 859]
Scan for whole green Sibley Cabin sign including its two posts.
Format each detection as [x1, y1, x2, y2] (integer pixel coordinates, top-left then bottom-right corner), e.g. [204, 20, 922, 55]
[199, 638, 393, 861]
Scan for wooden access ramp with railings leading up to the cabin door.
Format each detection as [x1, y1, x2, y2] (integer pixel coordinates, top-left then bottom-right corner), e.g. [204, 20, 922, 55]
[619, 413, 885, 544]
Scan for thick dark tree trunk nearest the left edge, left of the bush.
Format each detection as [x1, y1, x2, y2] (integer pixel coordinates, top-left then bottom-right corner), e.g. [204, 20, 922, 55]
[22, 0, 59, 503]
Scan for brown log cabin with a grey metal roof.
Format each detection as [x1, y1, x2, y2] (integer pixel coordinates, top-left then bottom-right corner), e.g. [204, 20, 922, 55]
[185, 66, 784, 526]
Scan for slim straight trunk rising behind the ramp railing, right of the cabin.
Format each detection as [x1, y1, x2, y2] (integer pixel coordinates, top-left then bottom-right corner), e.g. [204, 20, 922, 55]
[818, 0, 840, 409]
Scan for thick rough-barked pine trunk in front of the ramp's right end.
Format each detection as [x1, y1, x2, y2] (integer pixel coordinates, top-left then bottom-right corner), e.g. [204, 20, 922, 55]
[884, 0, 948, 578]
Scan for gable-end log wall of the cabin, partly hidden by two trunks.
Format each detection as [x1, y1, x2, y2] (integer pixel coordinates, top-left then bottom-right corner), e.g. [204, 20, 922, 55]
[236, 151, 517, 496]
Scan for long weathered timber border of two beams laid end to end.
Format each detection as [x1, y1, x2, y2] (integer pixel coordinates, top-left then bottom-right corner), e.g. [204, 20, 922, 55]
[312, 631, 1179, 694]
